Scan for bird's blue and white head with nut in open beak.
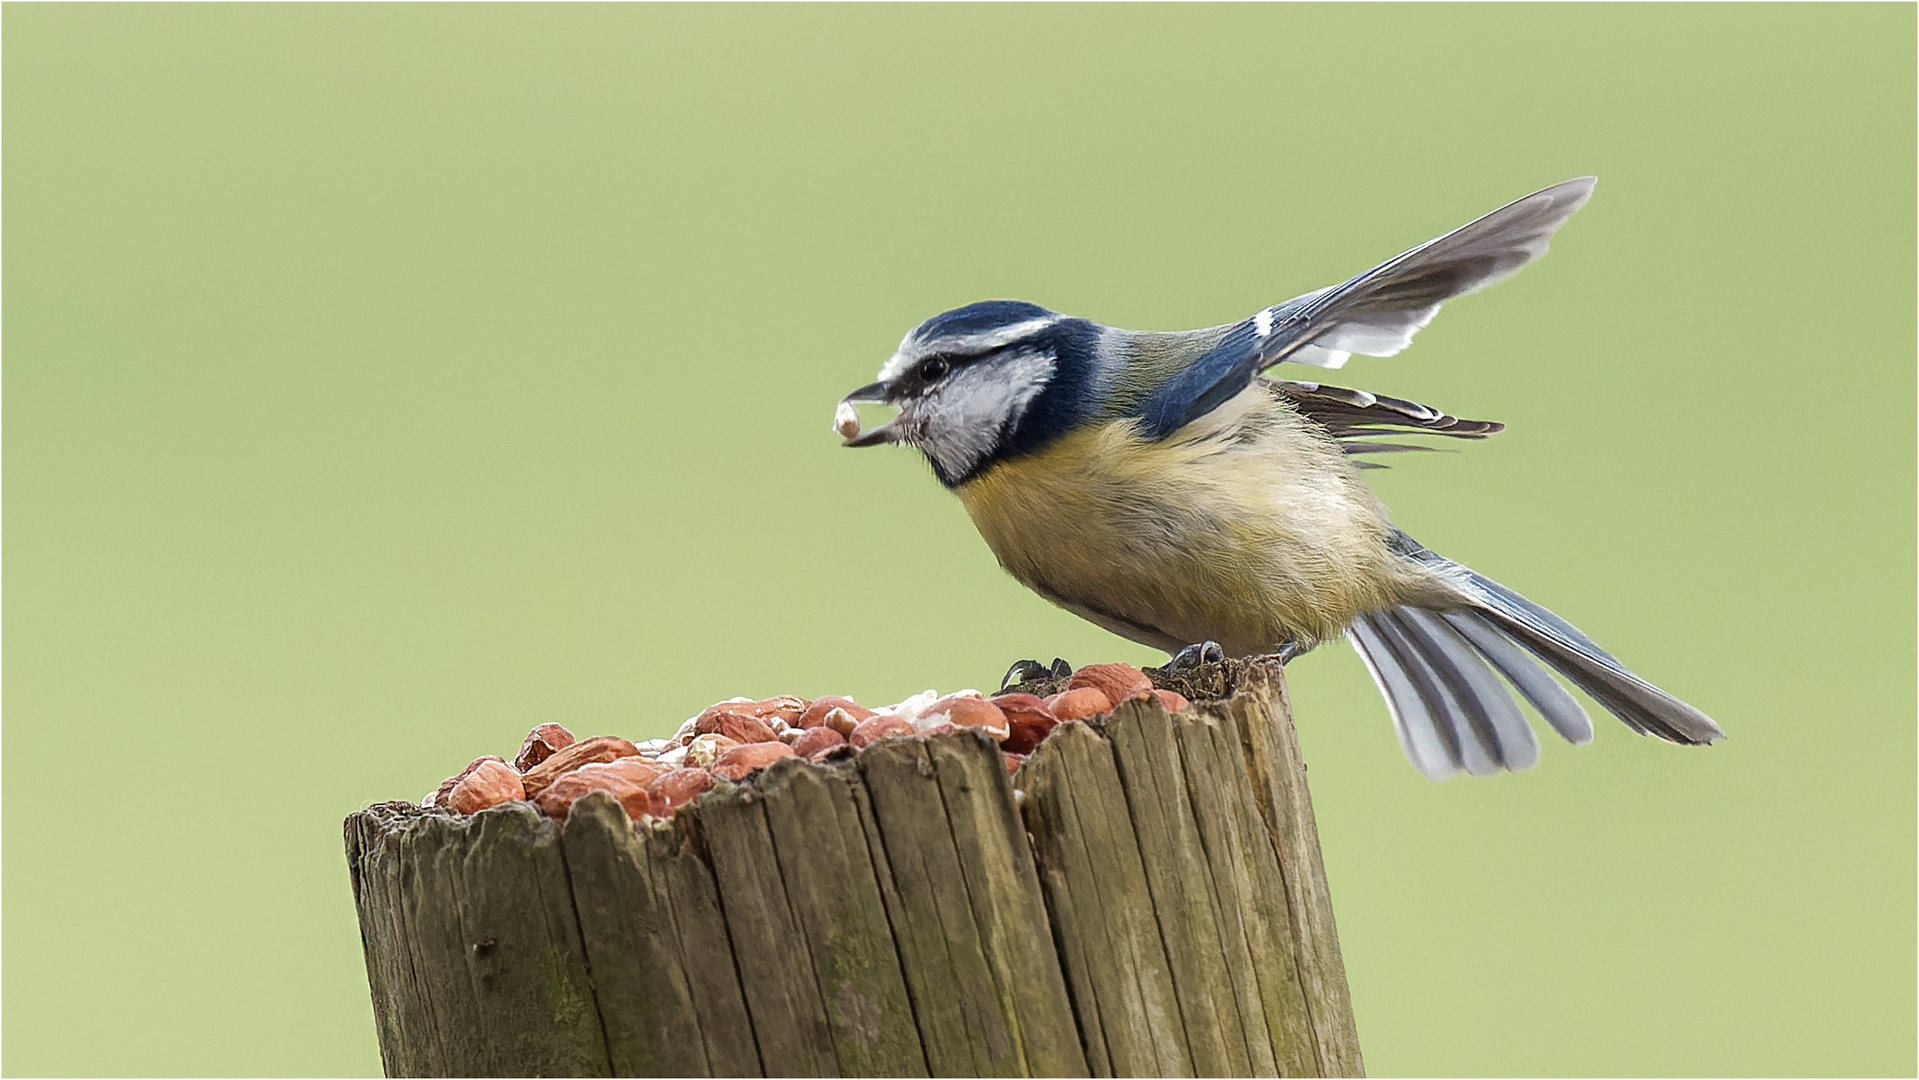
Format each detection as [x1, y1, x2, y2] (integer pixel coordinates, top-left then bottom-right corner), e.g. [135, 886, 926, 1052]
[833, 299, 1100, 487]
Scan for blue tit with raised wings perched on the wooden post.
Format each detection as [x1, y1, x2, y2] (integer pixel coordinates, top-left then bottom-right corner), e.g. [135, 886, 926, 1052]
[835, 176, 1723, 779]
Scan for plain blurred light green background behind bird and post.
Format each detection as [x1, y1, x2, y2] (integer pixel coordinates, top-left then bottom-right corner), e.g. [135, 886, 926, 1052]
[4, 4, 1915, 1074]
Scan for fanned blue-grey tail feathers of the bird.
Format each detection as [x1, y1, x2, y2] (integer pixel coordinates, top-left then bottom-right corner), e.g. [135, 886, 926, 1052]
[1351, 533, 1725, 781]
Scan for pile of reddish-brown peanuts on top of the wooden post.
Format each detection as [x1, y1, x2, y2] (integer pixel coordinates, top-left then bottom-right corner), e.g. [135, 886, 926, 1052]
[420, 664, 1186, 821]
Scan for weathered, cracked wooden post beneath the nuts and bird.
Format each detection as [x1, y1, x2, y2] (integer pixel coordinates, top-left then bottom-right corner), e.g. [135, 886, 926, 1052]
[345, 664, 1361, 1076]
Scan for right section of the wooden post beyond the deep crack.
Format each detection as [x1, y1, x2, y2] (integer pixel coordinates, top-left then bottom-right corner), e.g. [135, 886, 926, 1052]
[1015, 671, 1361, 1076]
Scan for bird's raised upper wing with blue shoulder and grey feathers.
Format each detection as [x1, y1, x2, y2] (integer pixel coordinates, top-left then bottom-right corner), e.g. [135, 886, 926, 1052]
[1140, 176, 1597, 437]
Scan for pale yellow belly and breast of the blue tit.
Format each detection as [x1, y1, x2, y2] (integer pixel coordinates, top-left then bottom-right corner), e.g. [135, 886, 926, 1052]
[958, 416, 1401, 656]
